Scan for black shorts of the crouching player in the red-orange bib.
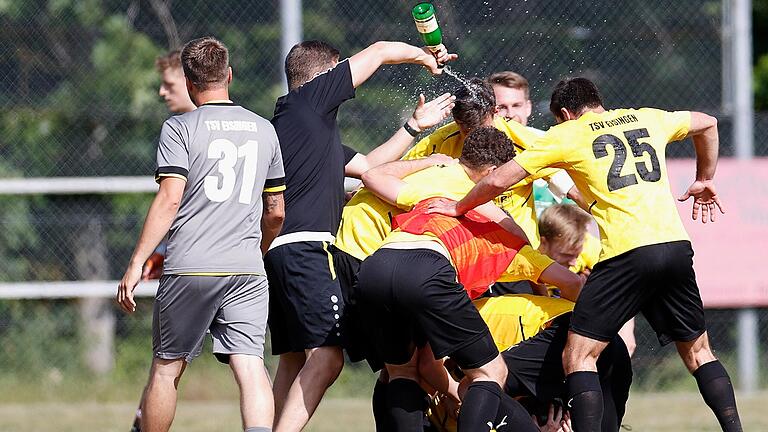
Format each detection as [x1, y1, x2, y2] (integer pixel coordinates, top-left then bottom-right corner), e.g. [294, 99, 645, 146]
[358, 249, 499, 369]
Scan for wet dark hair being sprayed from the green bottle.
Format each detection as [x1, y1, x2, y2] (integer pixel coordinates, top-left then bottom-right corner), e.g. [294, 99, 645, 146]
[451, 78, 496, 131]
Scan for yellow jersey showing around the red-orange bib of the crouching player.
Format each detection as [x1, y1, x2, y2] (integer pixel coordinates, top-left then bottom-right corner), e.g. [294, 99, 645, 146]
[383, 164, 554, 282]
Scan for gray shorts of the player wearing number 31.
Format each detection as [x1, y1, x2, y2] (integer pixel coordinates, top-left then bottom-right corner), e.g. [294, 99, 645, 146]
[152, 275, 269, 363]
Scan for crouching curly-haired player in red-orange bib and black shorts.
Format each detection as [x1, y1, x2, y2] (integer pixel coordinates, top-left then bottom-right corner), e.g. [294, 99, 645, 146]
[358, 128, 581, 431]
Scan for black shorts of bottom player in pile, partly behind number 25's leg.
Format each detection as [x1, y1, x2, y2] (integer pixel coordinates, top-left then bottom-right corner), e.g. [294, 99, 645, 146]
[501, 313, 632, 406]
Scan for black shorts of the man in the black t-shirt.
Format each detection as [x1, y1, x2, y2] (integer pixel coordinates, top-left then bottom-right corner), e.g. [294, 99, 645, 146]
[264, 241, 344, 355]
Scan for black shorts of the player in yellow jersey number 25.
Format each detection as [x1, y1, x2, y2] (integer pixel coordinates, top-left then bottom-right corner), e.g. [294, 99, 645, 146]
[571, 241, 705, 345]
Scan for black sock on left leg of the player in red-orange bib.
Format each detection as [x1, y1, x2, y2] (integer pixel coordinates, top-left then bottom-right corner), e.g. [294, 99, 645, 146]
[386, 378, 427, 432]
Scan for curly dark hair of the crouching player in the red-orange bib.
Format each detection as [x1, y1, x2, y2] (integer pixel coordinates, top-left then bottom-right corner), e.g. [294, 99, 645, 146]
[459, 126, 515, 170]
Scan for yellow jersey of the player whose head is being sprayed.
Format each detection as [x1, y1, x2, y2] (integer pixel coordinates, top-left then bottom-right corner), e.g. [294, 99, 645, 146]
[403, 117, 557, 248]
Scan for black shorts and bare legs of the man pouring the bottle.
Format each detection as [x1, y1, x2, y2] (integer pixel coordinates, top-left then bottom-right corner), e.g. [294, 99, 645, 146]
[265, 242, 344, 431]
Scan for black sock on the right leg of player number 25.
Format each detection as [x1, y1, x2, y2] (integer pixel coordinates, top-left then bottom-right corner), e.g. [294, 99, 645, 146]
[693, 360, 742, 432]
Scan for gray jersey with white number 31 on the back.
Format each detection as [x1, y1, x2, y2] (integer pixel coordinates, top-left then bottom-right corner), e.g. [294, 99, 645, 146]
[156, 103, 285, 274]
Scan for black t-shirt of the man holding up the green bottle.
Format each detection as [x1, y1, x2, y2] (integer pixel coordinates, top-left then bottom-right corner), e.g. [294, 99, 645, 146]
[272, 60, 356, 235]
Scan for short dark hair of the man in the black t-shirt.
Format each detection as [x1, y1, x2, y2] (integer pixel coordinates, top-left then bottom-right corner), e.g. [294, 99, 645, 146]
[285, 40, 339, 90]
